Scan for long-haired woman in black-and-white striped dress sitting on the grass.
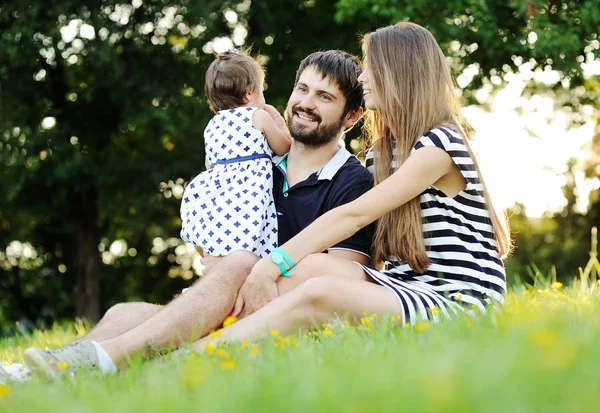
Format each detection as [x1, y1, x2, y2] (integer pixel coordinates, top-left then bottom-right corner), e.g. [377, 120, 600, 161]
[192, 22, 511, 348]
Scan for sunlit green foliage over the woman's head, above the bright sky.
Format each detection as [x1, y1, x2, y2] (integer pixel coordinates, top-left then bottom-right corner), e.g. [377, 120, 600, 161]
[336, 0, 600, 111]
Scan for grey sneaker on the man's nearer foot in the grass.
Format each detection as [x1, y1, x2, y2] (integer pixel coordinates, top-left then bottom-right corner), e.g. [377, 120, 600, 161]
[23, 340, 98, 380]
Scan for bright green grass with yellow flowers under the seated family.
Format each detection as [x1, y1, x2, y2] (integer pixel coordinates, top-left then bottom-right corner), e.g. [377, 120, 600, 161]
[0, 287, 600, 413]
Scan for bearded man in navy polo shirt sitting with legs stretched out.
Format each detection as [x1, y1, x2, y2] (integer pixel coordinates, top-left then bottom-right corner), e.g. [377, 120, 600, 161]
[23, 51, 372, 379]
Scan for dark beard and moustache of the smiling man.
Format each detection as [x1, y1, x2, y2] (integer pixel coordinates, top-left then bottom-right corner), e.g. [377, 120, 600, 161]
[288, 106, 344, 149]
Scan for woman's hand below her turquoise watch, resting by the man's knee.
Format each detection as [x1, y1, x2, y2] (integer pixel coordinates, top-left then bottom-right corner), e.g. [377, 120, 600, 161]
[232, 256, 281, 317]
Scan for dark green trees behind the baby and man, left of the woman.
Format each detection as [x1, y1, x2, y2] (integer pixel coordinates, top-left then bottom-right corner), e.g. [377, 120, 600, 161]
[0, 0, 368, 328]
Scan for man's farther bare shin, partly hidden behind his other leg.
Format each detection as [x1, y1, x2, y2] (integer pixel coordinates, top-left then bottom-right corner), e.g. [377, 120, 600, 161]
[77, 302, 163, 342]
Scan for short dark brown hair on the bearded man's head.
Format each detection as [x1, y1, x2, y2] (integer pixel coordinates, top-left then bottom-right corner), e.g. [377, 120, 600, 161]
[294, 50, 363, 116]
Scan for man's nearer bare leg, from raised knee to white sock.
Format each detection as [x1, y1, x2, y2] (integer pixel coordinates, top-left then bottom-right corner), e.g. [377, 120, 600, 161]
[99, 251, 258, 368]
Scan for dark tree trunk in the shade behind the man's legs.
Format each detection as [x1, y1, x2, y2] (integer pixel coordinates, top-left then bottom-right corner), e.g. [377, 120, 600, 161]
[75, 188, 101, 322]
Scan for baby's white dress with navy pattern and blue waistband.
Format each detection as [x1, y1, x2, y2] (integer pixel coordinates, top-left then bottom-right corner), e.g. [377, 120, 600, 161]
[181, 107, 277, 257]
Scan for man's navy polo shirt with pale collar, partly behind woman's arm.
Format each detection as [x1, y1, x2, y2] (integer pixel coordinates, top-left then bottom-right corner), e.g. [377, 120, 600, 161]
[273, 148, 374, 256]
